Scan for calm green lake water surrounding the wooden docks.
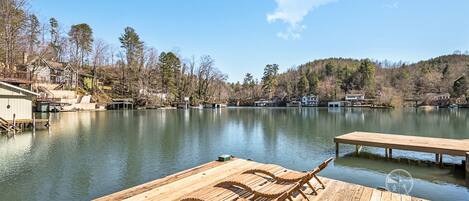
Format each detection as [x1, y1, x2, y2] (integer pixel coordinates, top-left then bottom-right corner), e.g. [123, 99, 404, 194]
[0, 108, 469, 201]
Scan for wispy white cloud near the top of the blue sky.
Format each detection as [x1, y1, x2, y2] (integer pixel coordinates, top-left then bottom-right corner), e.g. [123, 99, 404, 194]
[267, 0, 337, 40]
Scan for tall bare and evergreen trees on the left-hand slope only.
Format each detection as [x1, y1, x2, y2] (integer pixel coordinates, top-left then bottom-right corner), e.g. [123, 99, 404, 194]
[0, 0, 228, 105]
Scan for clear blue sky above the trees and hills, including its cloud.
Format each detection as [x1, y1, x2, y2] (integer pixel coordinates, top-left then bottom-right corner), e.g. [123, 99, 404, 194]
[31, 0, 469, 81]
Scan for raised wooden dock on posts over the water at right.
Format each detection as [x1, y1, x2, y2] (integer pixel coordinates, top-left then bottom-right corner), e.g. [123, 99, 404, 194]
[334, 132, 469, 164]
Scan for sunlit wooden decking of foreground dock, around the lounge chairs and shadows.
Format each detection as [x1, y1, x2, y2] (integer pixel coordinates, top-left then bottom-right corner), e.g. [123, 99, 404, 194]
[96, 159, 428, 201]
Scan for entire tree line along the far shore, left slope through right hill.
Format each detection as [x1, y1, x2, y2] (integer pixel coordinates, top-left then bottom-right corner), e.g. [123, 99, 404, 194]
[0, 0, 469, 105]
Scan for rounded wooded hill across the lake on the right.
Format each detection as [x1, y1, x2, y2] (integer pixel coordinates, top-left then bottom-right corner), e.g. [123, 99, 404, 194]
[233, 54, 469, 106]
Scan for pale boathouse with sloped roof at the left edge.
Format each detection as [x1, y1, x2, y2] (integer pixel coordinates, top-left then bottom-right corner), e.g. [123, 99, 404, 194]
[0, 81, 39, 121]
